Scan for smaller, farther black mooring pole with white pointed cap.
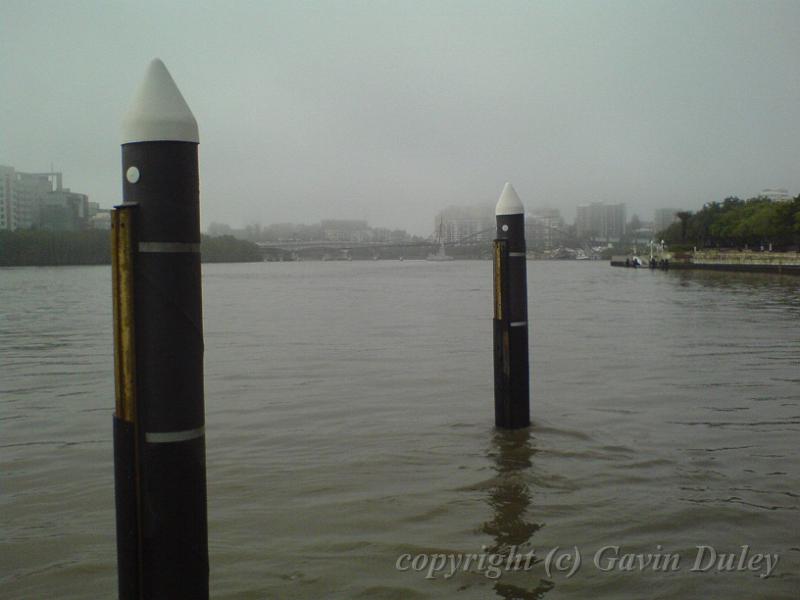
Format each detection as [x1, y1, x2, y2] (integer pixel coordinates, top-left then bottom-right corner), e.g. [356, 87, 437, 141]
[494, 183, 530, 429]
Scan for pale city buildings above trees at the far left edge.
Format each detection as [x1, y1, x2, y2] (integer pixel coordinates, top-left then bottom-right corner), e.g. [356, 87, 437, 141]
[0, 166, 89, 231]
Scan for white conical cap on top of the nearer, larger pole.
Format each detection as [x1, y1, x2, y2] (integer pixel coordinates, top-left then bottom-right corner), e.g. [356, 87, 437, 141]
[122, 58, 200, 144]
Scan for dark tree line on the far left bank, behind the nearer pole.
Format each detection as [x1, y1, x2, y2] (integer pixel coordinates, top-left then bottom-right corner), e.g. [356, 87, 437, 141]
[0, 229, 263, 267]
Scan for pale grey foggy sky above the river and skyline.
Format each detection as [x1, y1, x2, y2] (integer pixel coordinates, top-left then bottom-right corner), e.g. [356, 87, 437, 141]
[0, 0, 800, 235]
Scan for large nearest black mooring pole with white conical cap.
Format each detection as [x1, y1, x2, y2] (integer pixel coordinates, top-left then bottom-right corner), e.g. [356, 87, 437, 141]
[112, 60, 208, 600]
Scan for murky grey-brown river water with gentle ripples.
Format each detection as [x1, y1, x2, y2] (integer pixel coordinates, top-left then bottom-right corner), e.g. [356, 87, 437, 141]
[0, 261, 800, 600]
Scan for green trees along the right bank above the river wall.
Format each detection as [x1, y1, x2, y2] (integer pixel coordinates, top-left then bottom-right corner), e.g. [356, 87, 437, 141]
[658, 195, 800, 250]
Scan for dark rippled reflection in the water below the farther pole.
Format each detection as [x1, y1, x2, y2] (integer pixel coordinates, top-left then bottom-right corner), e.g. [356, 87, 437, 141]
[482, 428, 553, 600]
